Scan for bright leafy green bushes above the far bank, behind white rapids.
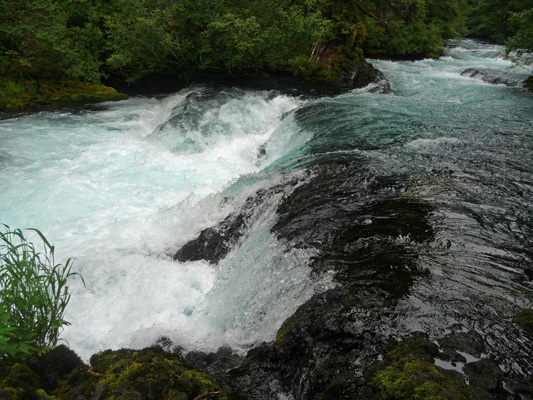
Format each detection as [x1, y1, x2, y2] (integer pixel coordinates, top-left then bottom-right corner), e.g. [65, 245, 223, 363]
[102, 0, 330, 81]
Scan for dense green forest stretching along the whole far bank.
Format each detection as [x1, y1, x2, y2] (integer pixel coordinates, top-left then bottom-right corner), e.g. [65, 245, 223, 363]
[0, 0, 533, 109]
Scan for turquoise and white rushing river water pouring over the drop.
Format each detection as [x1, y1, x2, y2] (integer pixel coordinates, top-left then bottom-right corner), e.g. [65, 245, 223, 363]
[0, 41, 533, 362]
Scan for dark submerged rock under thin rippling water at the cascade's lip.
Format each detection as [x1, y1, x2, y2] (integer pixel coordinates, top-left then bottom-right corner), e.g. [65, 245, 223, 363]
[273, 162, 432, 298]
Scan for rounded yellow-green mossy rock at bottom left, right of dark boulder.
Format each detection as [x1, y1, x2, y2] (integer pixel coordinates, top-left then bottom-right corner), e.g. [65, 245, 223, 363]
[58, 348, 228, 400]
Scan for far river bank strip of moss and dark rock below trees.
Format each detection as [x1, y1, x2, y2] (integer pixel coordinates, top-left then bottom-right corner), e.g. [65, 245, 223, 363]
[0, 61, 387, 115]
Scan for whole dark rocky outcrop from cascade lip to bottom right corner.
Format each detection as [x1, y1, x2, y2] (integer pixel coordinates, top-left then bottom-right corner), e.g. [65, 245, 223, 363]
[170, 159, 533, 400]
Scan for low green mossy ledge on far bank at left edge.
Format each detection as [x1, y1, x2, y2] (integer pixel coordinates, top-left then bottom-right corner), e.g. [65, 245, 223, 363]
[0, 79, 128, 111]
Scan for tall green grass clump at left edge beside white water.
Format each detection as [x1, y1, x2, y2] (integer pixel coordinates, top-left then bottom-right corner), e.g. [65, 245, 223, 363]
[0, 225, 83, 359]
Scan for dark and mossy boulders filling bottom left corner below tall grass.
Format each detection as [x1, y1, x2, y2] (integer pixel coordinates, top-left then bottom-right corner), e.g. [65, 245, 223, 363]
[0, 346, 229, 400]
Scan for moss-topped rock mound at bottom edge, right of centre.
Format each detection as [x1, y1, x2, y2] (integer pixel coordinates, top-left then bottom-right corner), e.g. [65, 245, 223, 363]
[371, 338, 472, 400]
